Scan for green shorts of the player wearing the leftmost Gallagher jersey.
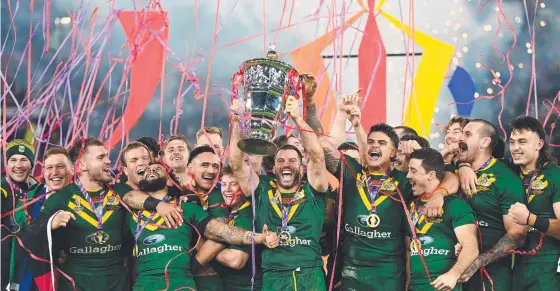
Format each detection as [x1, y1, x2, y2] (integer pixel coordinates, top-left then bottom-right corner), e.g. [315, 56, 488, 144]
[56, 268, 128, 291]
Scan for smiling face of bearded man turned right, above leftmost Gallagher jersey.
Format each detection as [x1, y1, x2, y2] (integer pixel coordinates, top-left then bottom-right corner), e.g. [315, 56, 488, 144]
[79, 145, 113, 183]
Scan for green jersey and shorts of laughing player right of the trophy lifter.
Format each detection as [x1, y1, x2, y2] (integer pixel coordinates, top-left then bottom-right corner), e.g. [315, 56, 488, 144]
[335, 155, 412, 290]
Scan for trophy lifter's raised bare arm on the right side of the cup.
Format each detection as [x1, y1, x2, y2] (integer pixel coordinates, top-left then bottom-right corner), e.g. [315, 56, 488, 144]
[286, 96, 329, 192]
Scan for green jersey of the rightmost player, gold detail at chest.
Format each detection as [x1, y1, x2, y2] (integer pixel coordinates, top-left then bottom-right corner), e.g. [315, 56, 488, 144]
[516, 163, 560, 263]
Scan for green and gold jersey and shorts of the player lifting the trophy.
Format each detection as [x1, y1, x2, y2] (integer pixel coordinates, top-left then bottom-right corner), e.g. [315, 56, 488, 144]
[254, 176, 327, 290]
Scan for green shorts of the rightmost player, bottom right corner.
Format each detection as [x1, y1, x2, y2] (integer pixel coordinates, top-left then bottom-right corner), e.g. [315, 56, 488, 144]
[512, 262, 560, 291]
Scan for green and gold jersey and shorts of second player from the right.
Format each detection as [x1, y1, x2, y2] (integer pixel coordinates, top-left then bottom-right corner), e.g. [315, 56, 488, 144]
[464, 158, 525, 291]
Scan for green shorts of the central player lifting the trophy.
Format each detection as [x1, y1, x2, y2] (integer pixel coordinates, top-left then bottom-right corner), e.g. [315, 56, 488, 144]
[262, 267, 326, 291]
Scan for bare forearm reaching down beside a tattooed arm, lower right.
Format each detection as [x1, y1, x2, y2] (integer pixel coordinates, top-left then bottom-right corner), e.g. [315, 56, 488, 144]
[432, 224, 478, 290]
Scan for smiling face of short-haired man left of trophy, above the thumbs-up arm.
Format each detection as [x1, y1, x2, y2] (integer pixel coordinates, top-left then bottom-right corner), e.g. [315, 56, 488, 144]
[189, 152, 220, 191]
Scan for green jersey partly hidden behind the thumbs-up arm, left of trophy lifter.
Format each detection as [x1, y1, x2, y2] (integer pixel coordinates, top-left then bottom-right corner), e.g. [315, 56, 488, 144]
[216, 201, 261, 290]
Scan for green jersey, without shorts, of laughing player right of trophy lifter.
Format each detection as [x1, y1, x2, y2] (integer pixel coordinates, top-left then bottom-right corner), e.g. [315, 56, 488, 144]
[335, 156, 412, 266]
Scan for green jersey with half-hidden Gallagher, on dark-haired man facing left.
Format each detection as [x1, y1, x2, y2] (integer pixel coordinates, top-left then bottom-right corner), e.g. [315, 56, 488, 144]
[409, 195, 475, 285]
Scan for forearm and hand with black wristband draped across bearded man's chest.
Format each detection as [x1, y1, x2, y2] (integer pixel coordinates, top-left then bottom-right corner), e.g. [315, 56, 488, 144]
[123, 190, 183, 228]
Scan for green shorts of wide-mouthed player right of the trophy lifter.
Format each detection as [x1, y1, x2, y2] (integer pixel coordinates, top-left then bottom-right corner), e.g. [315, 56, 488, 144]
[342, 262, 406, 291]
